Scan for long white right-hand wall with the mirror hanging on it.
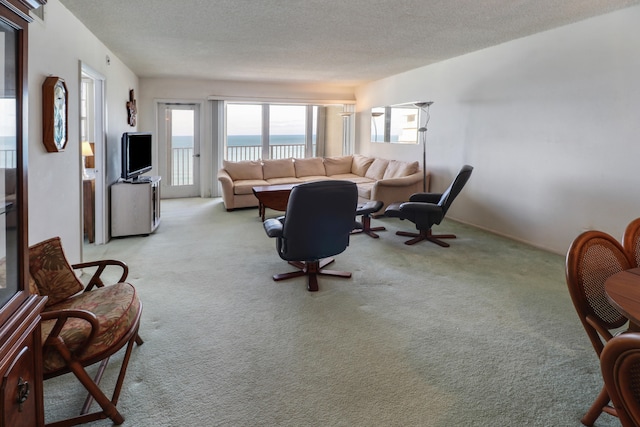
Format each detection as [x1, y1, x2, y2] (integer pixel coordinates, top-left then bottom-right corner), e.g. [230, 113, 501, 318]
[356, 6, 640, 253]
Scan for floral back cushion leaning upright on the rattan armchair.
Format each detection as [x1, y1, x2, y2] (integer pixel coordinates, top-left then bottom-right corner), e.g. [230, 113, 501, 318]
[29, 237, 84, 306]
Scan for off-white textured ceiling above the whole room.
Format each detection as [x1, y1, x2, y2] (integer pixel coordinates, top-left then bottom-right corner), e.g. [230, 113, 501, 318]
[60, 0, 640, 86]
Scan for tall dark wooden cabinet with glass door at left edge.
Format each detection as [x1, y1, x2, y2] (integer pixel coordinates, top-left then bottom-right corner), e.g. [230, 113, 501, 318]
[0, 0, 46, 427]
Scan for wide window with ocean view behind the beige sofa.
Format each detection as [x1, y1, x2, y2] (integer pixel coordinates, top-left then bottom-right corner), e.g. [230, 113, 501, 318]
[225, 103, 322, 161]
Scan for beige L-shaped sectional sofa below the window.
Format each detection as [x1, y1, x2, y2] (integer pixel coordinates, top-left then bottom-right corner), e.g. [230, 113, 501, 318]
[218, 154, 429, 212]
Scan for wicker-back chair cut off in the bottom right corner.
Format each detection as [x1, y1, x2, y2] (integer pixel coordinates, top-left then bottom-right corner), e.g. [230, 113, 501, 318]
[600, 333, 640, 427]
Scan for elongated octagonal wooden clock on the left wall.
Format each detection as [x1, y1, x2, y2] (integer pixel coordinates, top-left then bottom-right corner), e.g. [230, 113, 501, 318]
[42, 76, 69, 153]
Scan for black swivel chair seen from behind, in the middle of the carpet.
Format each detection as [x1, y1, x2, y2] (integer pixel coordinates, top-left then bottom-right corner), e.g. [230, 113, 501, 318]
[263, 181, 358, 291]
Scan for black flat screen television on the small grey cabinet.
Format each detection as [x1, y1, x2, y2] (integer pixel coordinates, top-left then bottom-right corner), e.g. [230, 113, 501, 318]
[121, 132, 153, 182]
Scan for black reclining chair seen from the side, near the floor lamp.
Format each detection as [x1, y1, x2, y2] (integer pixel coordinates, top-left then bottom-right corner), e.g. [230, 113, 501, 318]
[384, 165, 473, 247]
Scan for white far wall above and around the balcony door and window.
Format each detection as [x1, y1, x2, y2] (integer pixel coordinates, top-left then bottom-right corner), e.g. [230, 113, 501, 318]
[138, 78, 355, 197]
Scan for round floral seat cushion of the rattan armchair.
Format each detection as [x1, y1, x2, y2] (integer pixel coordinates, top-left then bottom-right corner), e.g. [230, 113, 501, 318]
[42, 283, 142, 374]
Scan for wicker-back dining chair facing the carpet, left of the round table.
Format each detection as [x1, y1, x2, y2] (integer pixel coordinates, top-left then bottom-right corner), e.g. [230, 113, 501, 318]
[566, 231, 631, 426]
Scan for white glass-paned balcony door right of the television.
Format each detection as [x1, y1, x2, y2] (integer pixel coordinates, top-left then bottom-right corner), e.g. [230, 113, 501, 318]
[158, 103, 200, 198]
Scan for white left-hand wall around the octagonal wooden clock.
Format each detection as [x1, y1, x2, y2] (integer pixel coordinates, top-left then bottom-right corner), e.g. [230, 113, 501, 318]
[28, 0, 138, 262]
